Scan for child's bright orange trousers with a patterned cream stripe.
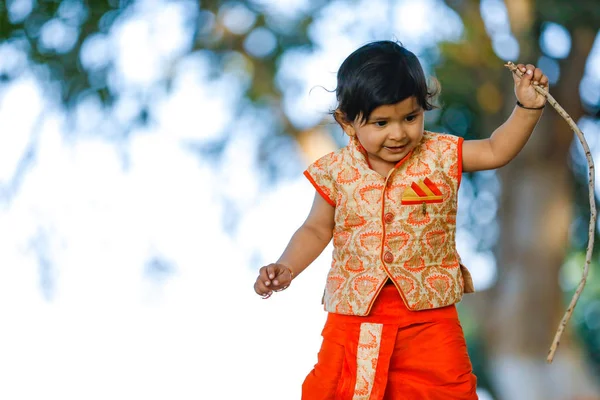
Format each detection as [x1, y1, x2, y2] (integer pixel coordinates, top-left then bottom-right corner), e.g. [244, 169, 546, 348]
[302, 285, 477, 400]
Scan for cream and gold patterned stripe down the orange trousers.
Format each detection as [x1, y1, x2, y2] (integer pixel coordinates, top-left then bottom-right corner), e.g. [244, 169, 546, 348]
[352, 323, 383, 400]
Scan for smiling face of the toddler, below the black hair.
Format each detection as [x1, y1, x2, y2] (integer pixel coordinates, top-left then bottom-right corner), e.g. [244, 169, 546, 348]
[344, 97, 424, 174]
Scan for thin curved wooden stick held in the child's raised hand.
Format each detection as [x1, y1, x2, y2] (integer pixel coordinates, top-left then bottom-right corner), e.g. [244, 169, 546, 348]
[504, 61, 596, 363]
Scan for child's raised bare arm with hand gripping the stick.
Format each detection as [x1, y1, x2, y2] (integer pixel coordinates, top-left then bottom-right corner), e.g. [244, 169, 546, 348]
[462, 64, 548, 172]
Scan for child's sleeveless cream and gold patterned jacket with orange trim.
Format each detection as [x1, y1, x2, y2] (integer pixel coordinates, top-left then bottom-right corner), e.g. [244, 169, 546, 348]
[304, 131, 474, 316]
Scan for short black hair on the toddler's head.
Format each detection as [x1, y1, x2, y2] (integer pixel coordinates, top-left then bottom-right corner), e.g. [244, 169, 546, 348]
[335, 40, 439, 122]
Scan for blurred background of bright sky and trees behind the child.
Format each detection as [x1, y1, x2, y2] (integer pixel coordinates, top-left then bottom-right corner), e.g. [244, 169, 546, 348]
[0, 0, 600, 400]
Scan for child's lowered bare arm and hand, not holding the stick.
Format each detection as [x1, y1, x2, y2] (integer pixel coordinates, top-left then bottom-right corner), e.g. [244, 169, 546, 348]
[254, 193, 335, 297]
